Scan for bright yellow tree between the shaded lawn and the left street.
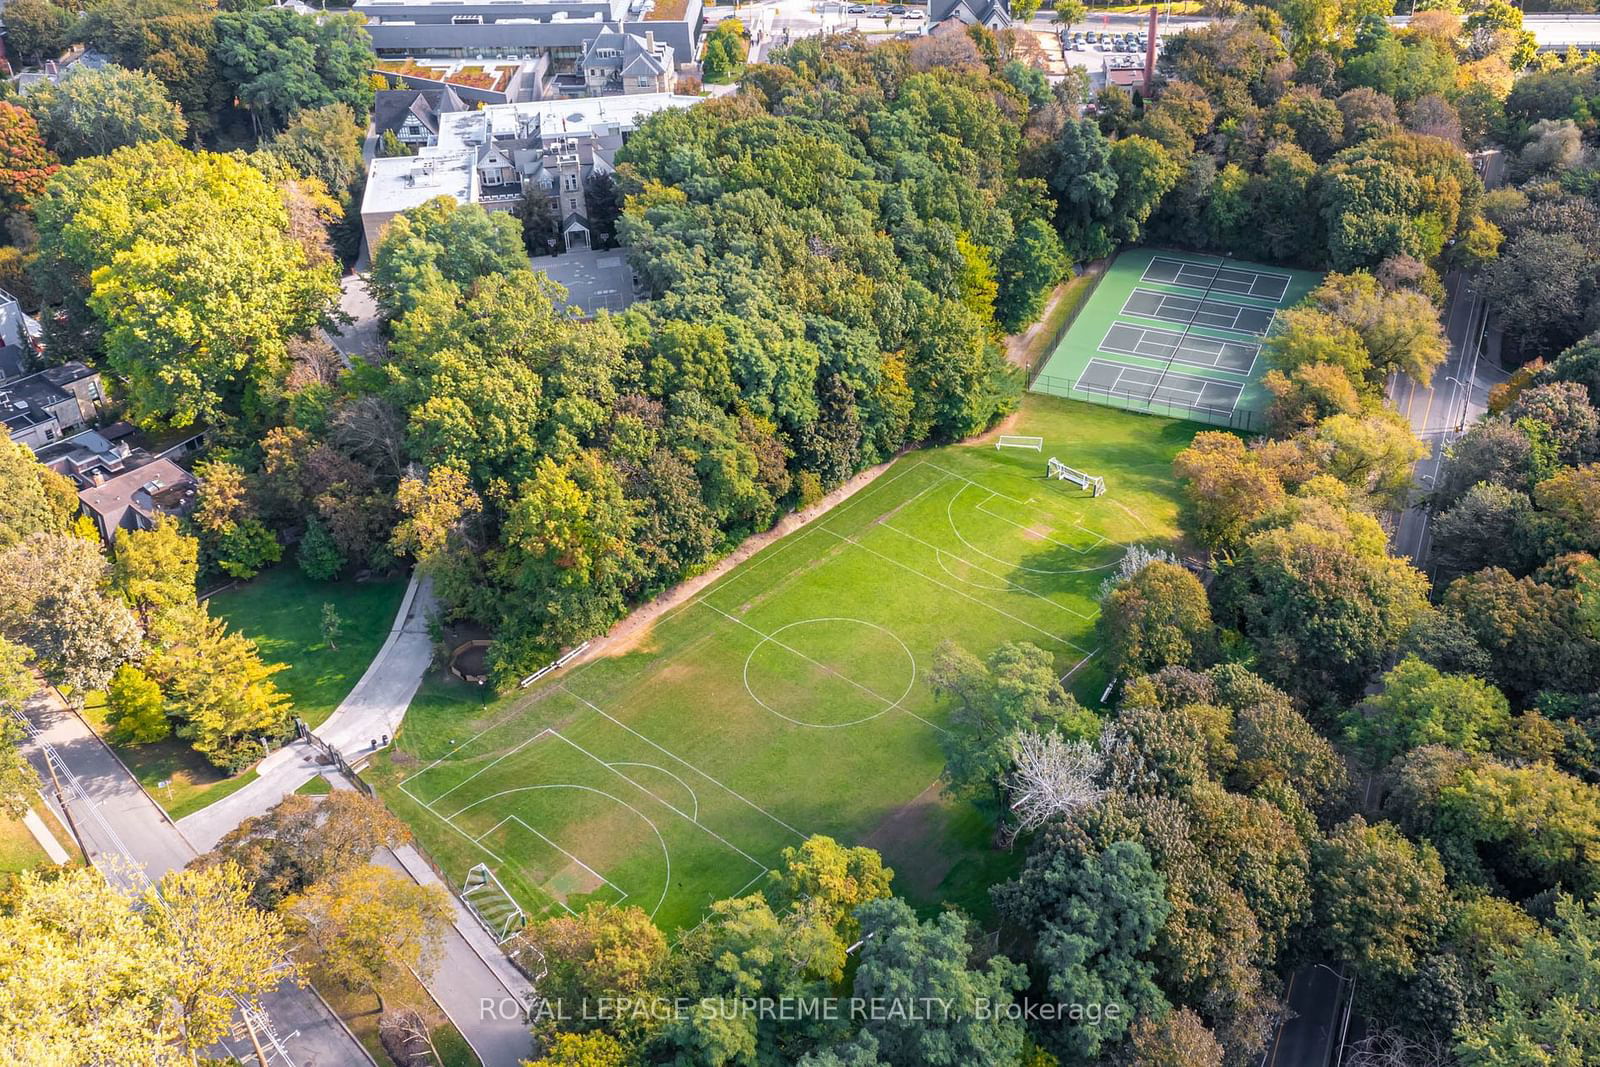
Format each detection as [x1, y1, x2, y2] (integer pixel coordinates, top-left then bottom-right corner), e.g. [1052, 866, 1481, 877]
[146, 605, 290, 771]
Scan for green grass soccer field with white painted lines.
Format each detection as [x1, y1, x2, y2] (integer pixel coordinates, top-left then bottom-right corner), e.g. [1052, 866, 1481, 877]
[374, 397, 1197, 929]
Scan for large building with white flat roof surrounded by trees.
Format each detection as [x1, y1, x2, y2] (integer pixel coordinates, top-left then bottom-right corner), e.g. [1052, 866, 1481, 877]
[362, 93, 699, 248]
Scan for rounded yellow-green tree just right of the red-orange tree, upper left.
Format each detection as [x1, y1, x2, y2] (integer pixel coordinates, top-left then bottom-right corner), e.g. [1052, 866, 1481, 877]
[24, 64, 187, 163]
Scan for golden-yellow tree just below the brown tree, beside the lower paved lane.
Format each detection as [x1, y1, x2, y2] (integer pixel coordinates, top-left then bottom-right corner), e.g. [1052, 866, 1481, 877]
[283, 864, 454, 1011]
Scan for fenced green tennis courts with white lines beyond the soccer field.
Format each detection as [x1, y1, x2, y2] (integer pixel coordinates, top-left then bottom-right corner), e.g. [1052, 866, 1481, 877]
[1032, 248, 1322, 430]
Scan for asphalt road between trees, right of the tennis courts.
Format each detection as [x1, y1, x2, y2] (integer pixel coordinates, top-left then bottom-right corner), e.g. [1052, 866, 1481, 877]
[1389, 275, 1506, 569]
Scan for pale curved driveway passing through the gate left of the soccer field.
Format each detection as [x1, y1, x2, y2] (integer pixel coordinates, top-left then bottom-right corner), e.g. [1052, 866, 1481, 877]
[178, 577, 434, 853]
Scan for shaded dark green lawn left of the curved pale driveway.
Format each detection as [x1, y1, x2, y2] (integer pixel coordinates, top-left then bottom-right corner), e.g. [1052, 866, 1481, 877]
[210, 565, 406, 726]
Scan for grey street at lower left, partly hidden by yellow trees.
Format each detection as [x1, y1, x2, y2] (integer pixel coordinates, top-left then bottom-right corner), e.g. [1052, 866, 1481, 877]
[22, 689, 371, 1067]
